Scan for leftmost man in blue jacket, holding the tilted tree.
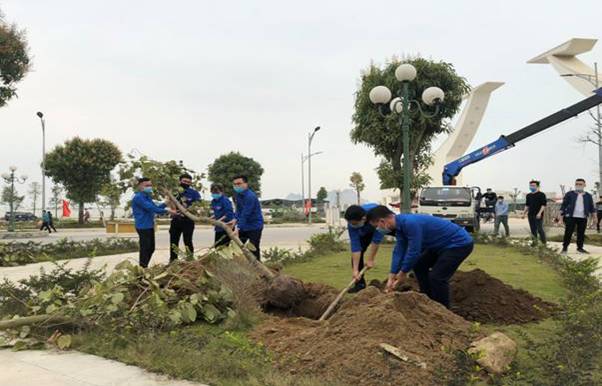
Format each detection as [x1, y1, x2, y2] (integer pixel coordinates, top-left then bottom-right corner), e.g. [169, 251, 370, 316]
[132, 177, 176, 268]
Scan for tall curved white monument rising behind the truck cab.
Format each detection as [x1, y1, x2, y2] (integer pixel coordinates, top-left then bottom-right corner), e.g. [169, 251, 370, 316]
[382, 82, 504, 204]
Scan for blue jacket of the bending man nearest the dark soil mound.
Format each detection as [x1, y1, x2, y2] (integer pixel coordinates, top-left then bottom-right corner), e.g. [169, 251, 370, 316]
[391, 214, 473, 273]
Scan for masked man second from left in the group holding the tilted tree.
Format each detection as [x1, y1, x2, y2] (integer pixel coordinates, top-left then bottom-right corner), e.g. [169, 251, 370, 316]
[169, 173, 201, 263]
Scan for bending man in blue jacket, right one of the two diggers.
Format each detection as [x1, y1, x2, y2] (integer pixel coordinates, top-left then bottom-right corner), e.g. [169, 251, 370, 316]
[367, 206, 474, 308]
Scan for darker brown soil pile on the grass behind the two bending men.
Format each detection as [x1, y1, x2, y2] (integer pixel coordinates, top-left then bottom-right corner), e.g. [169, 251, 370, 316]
[370, 269, 555, 324]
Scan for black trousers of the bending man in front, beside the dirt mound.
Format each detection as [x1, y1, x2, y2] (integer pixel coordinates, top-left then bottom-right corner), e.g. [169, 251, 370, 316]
[414, 243, 474, 308]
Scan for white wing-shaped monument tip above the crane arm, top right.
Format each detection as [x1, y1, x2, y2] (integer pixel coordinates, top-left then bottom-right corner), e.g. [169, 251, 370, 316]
[527, 38, 602, 96]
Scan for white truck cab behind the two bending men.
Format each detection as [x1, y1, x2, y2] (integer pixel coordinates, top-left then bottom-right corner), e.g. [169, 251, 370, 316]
[417, 185, 481, 232]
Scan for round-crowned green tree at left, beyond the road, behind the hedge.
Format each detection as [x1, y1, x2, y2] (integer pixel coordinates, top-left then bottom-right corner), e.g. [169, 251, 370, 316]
[46, 137, 121, 224]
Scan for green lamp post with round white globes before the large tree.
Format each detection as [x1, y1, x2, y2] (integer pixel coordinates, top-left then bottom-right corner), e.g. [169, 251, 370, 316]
[369, 63, 445, 213]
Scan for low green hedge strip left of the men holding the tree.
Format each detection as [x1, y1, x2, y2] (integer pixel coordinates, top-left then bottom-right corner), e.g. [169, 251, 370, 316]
[0, 238, 138, 267]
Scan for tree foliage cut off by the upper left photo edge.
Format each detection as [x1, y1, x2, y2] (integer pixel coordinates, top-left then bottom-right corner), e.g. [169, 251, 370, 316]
[0, 13, 30, 107]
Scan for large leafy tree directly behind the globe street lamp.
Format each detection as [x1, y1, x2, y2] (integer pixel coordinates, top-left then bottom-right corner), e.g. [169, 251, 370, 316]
[351, 58, 470, 196]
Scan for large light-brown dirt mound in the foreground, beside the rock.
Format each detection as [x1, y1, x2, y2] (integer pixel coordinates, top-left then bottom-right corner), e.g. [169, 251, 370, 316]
[252, 287, 471, 385]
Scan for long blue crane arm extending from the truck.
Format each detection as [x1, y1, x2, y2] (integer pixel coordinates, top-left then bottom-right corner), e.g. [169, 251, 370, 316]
[443, 88, 602, 185]
